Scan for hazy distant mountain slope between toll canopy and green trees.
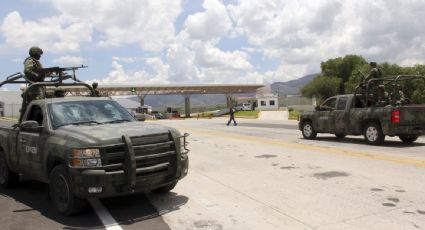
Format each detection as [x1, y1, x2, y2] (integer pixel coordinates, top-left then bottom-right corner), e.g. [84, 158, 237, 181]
[271, 74, 318, 96]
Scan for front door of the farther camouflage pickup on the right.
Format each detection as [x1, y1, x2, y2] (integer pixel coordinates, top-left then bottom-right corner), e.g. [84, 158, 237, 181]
[315, 97, 336, 133]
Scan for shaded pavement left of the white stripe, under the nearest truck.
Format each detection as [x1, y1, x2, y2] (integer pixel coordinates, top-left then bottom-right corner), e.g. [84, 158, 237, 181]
[0, 179, 104, 229]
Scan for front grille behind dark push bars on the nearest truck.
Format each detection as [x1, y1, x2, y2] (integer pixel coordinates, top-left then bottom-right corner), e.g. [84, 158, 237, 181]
[102, 133, 177, 180]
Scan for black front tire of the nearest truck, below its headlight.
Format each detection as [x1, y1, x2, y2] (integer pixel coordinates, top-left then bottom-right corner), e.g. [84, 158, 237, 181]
[49, 165, 87, 216]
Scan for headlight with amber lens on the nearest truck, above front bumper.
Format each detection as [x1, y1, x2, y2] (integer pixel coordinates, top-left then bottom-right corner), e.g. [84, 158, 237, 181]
[70, 149, 102, 167]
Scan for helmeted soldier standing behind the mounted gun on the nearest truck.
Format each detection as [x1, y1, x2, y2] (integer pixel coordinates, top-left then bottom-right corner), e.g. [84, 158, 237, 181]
[24, 46, 45, 102]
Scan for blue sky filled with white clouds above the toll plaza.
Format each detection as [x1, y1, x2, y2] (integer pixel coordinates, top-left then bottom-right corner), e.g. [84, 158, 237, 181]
[0, 0, 425, 89]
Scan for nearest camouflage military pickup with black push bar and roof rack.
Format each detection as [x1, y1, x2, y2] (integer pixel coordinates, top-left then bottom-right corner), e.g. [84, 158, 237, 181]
[0, 69, 189, 216]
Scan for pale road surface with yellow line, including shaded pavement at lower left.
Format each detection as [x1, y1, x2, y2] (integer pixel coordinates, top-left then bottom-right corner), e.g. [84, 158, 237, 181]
[0, 118, 425, 230]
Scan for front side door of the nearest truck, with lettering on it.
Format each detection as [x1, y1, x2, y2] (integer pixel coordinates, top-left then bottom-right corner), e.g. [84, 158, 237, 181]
[17, 105, 45, 177]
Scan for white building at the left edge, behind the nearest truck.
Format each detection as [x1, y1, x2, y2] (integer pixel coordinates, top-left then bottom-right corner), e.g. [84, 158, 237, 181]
[0, 91, 22, 117]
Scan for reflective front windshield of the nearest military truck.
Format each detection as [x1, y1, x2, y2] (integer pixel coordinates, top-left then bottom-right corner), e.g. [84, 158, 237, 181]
[48, 100, 135, 129]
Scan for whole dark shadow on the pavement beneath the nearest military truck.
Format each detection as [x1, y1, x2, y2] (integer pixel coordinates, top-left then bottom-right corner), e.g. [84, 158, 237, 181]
[0, 179, 188, 230]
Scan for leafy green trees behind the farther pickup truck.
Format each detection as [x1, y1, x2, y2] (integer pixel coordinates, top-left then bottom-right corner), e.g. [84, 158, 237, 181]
[301, 55, 425, 103]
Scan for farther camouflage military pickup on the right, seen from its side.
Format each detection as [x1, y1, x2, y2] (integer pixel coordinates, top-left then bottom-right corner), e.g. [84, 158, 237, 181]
[298, 76, 425, 145]
